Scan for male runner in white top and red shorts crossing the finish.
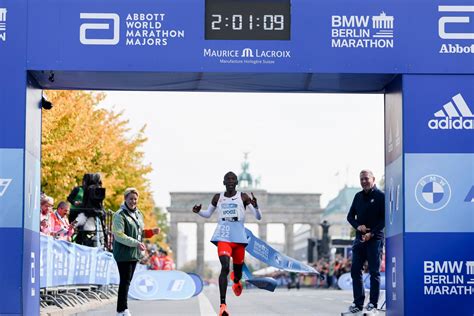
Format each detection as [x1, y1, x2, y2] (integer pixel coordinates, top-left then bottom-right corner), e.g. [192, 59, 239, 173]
[193, 172, 262, 316]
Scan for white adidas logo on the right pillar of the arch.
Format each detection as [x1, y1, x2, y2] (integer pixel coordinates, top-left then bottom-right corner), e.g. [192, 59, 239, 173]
[428, 93, 474, 129]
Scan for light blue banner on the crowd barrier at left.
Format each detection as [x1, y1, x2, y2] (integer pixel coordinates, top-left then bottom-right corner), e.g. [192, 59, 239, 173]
[40, 235, 119, 288]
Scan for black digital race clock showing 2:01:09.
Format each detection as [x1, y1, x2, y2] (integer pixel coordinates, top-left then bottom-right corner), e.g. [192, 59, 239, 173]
[205, 0, 291, 40]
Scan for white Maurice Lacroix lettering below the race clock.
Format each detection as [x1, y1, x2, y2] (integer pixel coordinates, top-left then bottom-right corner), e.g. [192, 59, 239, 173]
[203, 47, 291, 65]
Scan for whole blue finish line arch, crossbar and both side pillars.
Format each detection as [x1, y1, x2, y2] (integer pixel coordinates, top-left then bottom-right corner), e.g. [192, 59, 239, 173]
[0, 0, 474, 315]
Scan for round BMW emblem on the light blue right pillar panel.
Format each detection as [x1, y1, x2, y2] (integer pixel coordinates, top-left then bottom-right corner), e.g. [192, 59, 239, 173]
[415, 174, 451, 211]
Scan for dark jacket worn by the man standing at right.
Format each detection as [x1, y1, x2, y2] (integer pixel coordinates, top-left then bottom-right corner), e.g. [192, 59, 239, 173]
[347, 186, 385, 240]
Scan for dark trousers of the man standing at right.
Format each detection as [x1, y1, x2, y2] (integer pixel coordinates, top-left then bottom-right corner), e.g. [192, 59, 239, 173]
[351, 239, 383, 308]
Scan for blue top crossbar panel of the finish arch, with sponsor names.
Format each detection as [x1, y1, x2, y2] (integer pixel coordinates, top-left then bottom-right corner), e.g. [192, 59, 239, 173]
[27, 0, 474, 74]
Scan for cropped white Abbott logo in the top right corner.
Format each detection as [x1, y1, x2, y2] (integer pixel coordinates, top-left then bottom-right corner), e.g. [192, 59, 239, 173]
[438, 5, 474, 54]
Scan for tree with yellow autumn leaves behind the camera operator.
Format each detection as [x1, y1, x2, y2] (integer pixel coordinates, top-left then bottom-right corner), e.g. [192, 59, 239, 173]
[41, 91, 167, 239]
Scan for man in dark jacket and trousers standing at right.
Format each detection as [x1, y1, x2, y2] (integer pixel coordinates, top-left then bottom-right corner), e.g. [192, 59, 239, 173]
[347, 170, 385, 314]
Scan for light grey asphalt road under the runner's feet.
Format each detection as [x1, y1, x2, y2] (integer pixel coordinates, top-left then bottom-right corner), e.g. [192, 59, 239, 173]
[76, 287, 385, 316]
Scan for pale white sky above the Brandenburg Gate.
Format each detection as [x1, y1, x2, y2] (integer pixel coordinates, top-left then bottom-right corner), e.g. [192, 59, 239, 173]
[100, 91, 384, 266]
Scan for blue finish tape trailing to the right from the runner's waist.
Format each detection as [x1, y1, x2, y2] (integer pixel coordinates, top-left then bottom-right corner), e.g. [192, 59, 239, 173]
[245, 228, 319, 274]
